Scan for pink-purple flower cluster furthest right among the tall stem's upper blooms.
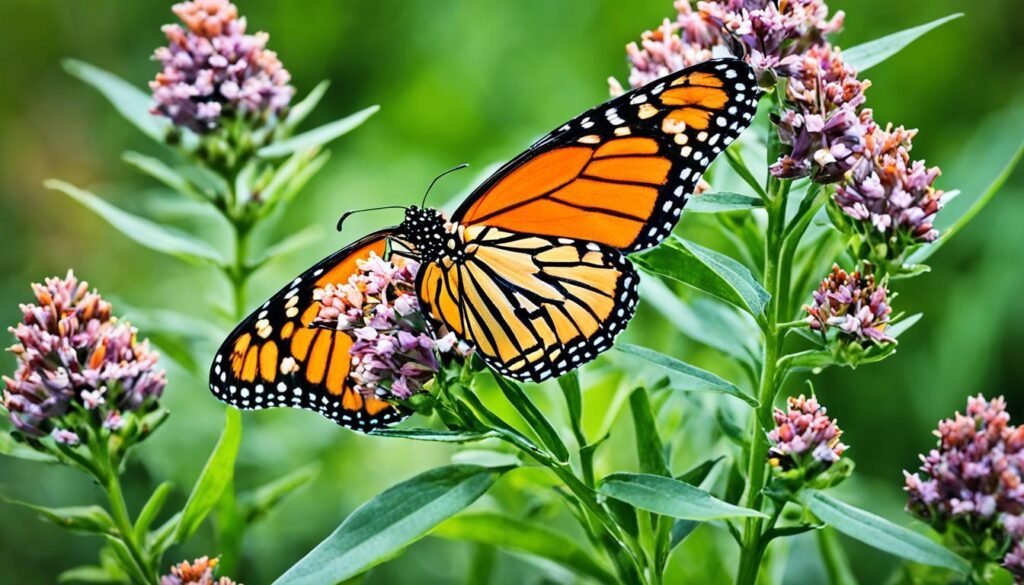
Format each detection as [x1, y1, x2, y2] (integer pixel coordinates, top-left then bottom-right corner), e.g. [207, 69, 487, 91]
[835, 122, 942, 244]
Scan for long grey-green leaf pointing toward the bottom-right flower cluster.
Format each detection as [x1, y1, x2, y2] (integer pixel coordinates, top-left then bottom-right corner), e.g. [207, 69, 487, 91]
[801, 490, 971, 575]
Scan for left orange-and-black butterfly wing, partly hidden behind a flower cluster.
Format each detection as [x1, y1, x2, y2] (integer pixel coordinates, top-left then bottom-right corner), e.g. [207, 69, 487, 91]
[210, 232, 409, 432]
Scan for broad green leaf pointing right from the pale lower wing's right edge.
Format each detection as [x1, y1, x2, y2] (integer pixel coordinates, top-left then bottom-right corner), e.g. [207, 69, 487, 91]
[630, 237, 771, 317]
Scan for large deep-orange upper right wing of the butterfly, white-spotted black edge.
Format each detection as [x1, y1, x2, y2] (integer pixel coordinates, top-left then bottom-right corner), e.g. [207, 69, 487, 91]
[453, 59, 759, 253]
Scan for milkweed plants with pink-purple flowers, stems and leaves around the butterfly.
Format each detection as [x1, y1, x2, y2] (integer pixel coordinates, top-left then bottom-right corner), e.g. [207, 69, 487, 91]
[2, 0, 1024, 585]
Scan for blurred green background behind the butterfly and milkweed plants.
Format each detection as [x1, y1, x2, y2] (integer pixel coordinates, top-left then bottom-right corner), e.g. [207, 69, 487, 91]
[0, 0, 1024, 584]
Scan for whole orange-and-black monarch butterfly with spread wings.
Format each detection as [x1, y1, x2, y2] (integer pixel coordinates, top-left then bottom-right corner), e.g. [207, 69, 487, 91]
[210, 58, 759, 431]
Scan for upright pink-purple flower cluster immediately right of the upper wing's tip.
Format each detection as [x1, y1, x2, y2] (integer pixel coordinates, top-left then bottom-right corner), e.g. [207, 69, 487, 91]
[769, 44, 870, 183]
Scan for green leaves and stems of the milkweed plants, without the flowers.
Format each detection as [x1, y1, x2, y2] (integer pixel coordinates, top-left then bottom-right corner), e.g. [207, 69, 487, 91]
[0, 1, 1022, 583]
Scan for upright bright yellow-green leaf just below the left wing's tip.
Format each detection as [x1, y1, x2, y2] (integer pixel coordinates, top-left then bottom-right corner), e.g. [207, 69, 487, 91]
[174, 408, 242, 542]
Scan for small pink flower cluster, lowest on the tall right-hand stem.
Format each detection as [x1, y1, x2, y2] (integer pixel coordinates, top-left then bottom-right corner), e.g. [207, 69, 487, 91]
[768, 394, 847, 469]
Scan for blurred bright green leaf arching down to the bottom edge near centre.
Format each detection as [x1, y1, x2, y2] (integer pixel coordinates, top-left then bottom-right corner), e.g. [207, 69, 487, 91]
[431, 512, 616, 583]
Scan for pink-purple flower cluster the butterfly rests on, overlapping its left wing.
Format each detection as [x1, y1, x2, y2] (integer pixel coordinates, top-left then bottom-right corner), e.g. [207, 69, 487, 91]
[313, 252, 468, 400]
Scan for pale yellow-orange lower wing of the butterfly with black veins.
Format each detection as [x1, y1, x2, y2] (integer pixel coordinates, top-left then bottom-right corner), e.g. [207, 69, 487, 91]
[417, 225, 637, 382]
